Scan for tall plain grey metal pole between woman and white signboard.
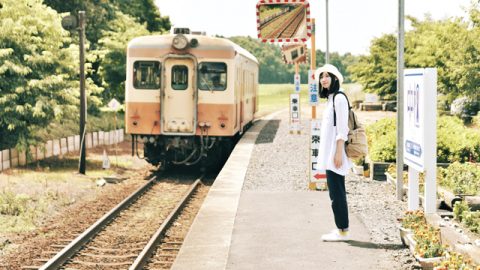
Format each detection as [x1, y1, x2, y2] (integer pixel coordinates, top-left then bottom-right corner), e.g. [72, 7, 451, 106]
[396, 0, 405, 200]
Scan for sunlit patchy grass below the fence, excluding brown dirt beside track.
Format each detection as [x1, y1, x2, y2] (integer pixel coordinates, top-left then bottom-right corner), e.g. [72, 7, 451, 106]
[0, 146, 139, 234]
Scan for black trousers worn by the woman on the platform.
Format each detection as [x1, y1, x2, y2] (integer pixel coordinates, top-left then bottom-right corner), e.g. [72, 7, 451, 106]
[327, 170, 348, 229]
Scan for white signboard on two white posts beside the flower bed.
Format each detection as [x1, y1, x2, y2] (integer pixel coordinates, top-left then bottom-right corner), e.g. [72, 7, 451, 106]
[402, 68, 437, 214]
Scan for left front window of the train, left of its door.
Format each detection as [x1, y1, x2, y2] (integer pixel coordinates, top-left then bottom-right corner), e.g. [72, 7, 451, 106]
[133, 61, 161, 89]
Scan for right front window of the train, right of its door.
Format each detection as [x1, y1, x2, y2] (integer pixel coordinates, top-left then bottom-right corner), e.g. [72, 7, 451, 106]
[198, 62, 227, 91]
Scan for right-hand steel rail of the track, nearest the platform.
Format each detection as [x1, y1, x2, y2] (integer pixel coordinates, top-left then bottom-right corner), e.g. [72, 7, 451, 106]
[128, 174, 205, 270]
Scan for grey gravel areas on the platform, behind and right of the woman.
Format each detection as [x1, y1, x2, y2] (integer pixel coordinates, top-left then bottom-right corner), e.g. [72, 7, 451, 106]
[243, 110, 416, 269]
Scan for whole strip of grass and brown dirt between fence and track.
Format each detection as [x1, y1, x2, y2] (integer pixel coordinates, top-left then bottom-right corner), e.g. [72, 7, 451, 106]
[0, 139, 155, 269]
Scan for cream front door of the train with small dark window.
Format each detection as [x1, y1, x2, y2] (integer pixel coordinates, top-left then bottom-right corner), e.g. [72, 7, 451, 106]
[162, 58, 197, 134]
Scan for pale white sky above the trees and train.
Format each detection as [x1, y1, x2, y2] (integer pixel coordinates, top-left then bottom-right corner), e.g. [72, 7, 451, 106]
[155, 0, 470, 55]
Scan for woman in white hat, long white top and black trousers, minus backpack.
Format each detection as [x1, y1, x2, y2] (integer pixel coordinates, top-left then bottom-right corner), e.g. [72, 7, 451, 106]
[315, 64, 352, 242]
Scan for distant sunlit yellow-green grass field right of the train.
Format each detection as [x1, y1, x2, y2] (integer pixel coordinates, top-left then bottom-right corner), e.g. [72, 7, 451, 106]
[257, 84, 364, 117]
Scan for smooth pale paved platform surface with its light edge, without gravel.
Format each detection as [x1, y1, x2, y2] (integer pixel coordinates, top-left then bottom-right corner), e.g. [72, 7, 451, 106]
[172, 110, 394, 270]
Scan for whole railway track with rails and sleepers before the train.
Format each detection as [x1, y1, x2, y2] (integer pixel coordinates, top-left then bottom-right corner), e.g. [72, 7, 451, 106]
[22, 173, 208, 269]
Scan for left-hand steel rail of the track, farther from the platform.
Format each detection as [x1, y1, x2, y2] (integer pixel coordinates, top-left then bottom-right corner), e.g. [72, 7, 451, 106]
[39, 176, 157, 270]
